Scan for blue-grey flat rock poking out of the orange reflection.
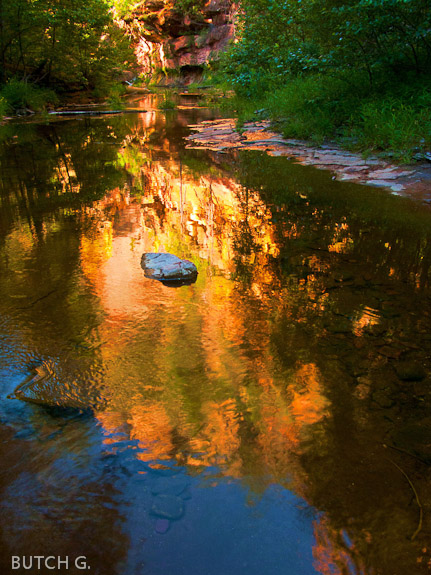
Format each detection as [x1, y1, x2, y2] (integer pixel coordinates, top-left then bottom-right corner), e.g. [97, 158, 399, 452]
[141, 253, 198, 284]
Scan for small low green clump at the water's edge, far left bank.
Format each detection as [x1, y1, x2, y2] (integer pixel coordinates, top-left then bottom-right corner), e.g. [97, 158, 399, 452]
[0, 78, 58, 111]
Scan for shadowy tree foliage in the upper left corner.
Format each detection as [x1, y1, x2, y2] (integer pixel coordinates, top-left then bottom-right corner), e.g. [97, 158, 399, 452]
[0, 0, 132, 92]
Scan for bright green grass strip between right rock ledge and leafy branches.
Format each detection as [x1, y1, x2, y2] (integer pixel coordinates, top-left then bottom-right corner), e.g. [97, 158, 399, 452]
[223, 74, 431, 162]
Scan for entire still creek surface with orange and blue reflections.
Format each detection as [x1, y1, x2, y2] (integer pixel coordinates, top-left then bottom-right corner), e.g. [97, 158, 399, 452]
[0, 100, 431, 575]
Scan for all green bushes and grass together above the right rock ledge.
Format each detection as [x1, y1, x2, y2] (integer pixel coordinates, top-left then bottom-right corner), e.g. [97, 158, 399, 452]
[221, 0, 431, 161]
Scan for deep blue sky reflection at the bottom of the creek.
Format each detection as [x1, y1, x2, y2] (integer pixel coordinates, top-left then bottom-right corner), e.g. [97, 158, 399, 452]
[120, 464, 316, 575]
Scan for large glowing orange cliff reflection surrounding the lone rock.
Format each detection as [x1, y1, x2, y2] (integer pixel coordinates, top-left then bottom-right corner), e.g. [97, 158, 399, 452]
[81, 135, 340, 564]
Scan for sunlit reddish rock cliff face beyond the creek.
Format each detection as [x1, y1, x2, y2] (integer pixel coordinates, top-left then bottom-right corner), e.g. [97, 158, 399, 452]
[115, 0, 238, 80]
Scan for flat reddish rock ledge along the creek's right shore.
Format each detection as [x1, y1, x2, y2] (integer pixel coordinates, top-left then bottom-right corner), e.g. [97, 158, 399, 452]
[186, 119, 431, 203]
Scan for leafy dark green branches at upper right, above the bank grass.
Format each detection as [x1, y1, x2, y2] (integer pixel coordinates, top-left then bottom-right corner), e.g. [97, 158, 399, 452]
[223, 0, 431, 96]
